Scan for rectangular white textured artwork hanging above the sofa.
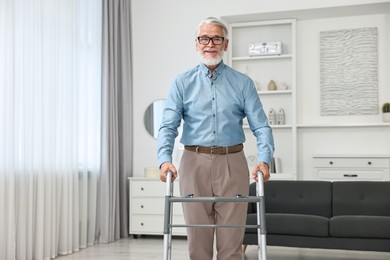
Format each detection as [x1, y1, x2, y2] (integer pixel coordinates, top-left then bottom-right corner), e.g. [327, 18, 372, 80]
[320, 28, 378, 116]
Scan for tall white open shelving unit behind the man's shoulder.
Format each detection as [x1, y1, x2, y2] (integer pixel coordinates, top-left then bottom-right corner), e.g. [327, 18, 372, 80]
[228, 19, 297, 179]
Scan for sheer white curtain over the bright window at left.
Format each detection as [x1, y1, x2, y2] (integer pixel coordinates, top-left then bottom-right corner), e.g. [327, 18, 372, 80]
[0, 0, 102, 260]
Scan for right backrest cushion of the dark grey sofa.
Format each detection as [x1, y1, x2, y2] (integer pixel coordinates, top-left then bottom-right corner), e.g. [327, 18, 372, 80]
[333, 181, 390, 217]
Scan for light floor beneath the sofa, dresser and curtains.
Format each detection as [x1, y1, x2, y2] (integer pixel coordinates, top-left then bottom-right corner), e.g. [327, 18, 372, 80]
[58, 237, 390, 260]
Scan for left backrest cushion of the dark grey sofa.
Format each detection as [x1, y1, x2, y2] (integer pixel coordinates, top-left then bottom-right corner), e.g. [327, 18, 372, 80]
[264, 181, 332, 217]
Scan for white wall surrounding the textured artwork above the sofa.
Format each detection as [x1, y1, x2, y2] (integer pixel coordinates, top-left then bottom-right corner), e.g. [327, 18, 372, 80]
[297, 14, 390, 124]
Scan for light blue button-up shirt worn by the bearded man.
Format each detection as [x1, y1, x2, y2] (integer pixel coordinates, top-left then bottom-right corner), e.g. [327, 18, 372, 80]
[157, 62, 274, 165]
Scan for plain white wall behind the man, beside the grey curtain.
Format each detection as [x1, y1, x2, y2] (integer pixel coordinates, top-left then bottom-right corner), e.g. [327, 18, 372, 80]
[132, 0, 389, 176]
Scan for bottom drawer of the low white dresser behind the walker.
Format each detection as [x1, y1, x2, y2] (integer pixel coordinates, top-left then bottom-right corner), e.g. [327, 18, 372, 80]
[130, 215, 186, 235]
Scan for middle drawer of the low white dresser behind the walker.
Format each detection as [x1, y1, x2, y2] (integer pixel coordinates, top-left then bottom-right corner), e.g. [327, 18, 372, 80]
[130, 198, 183, 215]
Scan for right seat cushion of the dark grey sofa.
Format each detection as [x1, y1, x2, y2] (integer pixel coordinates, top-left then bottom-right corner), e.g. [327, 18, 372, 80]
[330, 215, 390, 238]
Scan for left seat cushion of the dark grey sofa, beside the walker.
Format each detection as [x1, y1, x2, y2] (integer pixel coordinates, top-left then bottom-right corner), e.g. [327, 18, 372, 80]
[245, 213, 329, 237]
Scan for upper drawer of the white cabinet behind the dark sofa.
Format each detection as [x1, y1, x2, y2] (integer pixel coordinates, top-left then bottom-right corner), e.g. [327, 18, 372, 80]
[314, 157, 390, 168]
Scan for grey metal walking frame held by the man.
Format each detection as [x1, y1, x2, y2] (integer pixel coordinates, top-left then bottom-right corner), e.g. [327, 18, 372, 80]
[163, 171, 267, 260]
